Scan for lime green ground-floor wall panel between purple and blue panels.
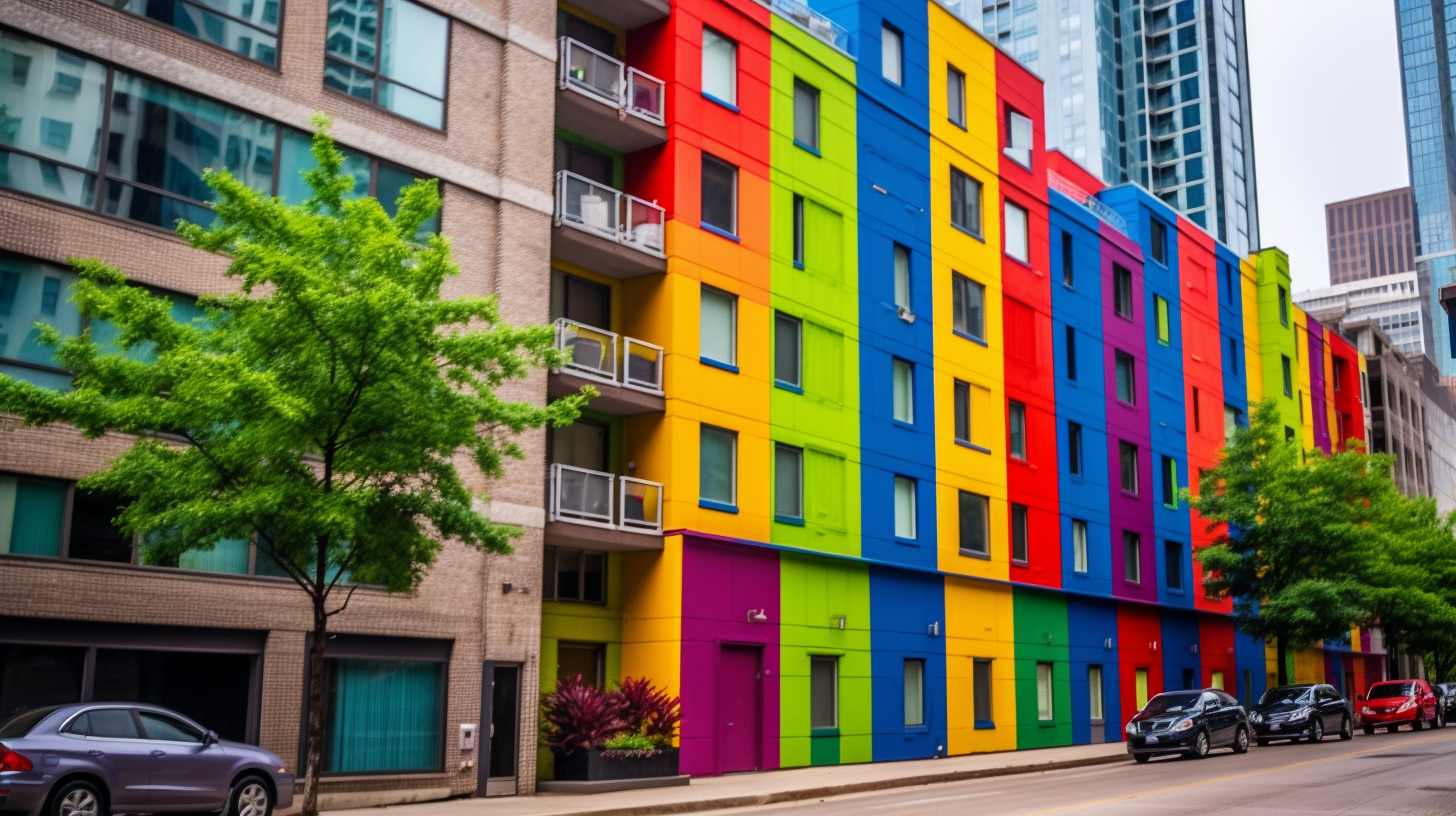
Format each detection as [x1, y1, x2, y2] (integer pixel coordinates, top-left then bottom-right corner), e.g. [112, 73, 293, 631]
[779, 552, 872, 768]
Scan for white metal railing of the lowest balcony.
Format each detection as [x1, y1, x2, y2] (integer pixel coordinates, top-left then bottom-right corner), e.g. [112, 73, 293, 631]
[549, 465, 662, 535]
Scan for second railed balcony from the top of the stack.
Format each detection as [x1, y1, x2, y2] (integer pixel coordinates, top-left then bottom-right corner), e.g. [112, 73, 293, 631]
[550, 170, 667, 280]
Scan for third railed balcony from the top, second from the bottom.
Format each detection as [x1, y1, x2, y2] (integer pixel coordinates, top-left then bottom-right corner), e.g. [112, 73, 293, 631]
[546, 318, 667, 417]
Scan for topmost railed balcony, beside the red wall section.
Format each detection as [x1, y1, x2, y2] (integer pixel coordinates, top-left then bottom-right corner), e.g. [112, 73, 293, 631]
[556, 36, 667, 153]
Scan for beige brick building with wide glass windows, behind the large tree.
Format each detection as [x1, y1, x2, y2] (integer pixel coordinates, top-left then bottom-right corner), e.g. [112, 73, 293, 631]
[0, 0, 555, 807]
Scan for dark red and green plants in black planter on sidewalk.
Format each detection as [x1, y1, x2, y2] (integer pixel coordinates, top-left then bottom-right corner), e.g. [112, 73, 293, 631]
[542, 676, 681, 782]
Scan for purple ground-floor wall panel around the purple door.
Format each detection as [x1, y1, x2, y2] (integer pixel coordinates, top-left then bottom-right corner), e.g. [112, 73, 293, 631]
[680, 536, 779, 775]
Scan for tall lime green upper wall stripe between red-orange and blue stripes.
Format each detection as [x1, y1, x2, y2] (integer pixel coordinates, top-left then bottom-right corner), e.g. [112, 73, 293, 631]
[769, 16, 868, 556]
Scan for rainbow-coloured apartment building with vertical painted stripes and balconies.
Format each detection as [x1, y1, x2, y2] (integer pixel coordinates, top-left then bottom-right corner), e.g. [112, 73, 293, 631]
[540, 0, 1382, 775]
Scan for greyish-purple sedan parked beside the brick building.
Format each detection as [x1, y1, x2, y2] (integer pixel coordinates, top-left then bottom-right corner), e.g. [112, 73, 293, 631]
[0, 702, 293, 816]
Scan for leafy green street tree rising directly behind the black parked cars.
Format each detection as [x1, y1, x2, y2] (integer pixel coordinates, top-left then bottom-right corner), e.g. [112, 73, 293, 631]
[1191, 401, 1402, 683]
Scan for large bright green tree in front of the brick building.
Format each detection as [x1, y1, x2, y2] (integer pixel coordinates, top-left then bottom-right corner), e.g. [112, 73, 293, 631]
[0, 115, 587, 816]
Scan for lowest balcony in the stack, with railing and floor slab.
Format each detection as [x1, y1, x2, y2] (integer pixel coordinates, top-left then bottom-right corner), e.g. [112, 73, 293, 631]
[546, 465, 662, 552]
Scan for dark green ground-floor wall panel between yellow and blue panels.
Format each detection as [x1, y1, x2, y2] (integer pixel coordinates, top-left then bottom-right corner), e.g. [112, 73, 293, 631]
[1012, 587, 1072, 749]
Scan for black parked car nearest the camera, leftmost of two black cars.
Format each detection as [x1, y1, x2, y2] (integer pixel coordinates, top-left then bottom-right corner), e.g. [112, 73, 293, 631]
[1127, 689, 1251, 762]
